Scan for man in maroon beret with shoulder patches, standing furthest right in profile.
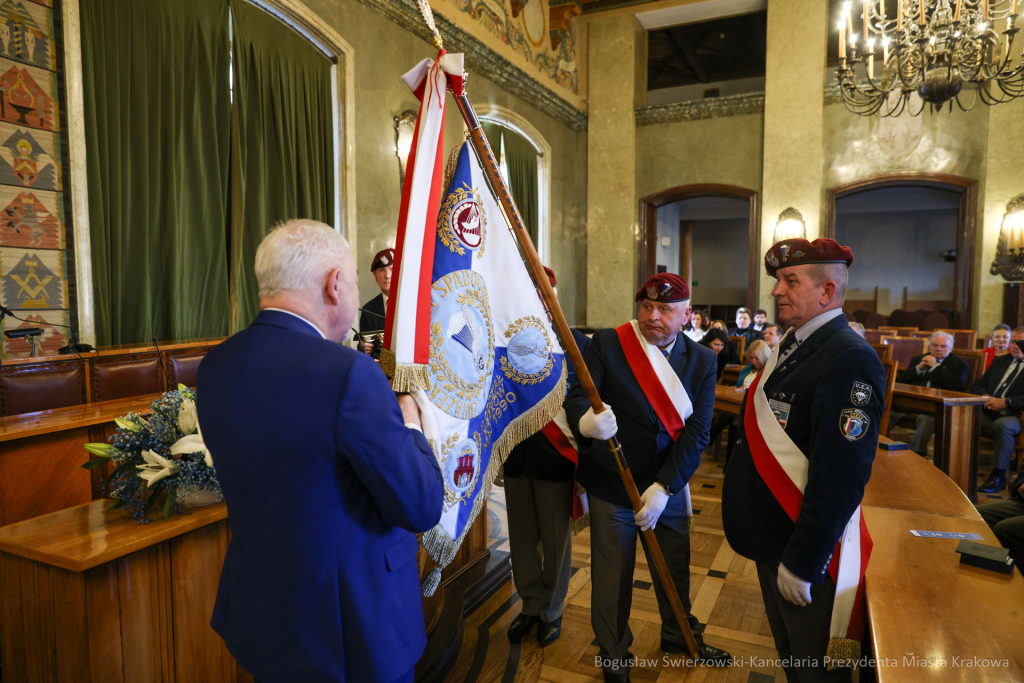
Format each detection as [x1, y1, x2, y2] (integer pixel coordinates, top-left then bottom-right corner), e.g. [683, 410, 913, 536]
[722, 240, 886, 683]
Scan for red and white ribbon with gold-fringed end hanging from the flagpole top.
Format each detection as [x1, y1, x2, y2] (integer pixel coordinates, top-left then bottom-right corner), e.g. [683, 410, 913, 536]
[384, 50, 463, 391]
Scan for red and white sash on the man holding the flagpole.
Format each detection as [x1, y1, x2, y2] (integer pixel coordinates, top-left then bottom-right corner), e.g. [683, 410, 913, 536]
[615, 321, 693, 518]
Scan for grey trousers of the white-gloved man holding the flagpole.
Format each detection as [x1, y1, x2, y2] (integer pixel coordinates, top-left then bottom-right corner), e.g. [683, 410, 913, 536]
[589, 494, 703, 663]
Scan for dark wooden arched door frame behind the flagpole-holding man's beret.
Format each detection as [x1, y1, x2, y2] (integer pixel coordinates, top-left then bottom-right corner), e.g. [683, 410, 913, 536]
[637, 183, 761, 308]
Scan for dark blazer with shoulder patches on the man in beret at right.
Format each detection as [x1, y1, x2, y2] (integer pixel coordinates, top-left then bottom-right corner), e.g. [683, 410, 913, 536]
[722, 315, 886, 585]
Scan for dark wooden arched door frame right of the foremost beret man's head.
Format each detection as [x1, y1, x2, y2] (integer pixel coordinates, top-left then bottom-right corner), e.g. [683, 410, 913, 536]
[824, 172, 978, 328]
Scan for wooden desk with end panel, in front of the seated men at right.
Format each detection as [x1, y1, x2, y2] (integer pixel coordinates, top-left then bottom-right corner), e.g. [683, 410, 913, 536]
[892, 383, 985, 503]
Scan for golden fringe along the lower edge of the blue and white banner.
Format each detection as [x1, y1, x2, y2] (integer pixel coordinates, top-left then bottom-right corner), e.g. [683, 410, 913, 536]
[421, 361, 567, 598]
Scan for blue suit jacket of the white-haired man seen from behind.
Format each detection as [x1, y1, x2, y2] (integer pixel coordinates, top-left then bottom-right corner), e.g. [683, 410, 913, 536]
[198, 310, 443, 683]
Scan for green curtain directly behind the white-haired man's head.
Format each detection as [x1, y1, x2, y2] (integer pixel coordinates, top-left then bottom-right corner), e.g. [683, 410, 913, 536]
[230, 0, 335, 331]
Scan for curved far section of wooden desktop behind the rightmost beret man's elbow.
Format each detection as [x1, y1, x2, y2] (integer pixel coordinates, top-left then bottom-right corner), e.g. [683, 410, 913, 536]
[861, 437, 981, 520]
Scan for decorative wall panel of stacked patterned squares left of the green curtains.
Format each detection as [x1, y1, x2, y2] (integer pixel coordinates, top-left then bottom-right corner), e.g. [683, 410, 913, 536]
[0, 0, 73, 358]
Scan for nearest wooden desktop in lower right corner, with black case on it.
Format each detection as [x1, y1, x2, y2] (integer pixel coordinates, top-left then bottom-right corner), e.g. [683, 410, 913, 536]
[863, 507, 1024, 683]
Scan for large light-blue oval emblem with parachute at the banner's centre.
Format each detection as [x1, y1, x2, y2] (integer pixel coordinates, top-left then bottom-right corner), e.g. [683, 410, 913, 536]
[430, 270, 495, 420]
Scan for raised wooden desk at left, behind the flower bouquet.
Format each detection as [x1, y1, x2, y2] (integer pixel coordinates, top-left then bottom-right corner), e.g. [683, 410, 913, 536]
[0, 394, 159, 526]
